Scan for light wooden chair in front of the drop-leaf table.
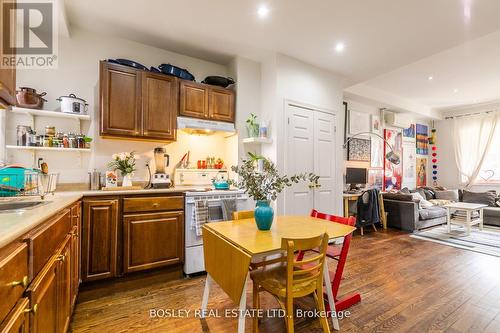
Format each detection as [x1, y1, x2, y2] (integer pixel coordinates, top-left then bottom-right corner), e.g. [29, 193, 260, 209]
[250, 234, 330, 333]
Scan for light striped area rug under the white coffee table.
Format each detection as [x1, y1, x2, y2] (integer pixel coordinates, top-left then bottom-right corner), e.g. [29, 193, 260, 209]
[410, 225, 500, 257]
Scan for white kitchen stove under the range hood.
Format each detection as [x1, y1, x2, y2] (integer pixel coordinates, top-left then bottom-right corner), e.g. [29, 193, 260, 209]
[178, 169, 252, 274]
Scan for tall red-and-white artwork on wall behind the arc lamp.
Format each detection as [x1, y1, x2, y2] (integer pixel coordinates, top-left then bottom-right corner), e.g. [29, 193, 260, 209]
[384, 129, 403, 191]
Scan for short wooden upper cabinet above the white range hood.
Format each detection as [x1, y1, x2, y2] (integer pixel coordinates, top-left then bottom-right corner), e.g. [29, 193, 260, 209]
[179, 81, 234, 122]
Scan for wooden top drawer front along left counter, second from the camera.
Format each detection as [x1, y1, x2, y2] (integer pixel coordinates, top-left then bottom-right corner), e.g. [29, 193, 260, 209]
[23, 209, 72, 278]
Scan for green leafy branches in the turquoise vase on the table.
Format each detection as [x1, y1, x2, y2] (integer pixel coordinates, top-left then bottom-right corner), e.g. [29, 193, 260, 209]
[229, 153, 319, 201]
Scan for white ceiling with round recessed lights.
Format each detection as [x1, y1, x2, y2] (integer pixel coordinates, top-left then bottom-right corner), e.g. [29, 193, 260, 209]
[65, 0, 500, 111]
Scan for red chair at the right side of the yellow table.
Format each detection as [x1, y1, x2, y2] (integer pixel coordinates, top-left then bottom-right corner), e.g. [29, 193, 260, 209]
[297, 209, 361, 311]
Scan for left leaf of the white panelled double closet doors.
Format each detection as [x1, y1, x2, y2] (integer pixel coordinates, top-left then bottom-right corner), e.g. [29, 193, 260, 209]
[285, 105, 314, 215]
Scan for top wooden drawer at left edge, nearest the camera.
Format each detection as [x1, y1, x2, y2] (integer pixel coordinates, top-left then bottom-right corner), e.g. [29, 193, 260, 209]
[0, 243, 28, 322]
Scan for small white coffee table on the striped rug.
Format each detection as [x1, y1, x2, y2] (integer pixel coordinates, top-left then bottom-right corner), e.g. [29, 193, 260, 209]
[444, 202, 488, 235]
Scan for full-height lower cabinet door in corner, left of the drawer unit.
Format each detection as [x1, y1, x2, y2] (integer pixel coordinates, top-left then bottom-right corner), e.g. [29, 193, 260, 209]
[82, 199, 118, 281]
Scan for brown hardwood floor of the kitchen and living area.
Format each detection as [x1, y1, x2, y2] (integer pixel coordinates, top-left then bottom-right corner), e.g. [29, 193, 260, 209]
[71, 230, 500, 333]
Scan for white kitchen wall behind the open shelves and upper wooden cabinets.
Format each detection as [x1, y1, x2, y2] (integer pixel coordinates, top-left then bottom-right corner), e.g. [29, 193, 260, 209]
[7, 29, 239, 182]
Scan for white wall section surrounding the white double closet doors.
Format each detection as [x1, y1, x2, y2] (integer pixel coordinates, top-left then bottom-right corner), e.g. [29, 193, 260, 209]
[261, 54, 344, 214]
